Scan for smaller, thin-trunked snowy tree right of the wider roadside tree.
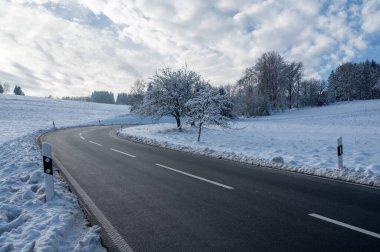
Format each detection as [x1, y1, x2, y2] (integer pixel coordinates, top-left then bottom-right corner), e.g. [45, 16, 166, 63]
[186, 84, 229, 142]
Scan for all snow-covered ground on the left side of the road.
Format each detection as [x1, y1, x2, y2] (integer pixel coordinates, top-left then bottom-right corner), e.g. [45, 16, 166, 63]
[0, 95, 139, 252]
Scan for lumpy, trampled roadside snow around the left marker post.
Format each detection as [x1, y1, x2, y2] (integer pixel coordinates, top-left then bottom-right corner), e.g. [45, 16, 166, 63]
[0, 132, 104, 251]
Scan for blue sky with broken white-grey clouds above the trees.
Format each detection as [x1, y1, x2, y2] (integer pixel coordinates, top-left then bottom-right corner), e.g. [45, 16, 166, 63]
[0, 0, 380, 97]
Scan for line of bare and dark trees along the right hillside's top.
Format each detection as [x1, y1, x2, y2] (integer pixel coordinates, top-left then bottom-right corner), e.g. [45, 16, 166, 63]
[230, 52, 380, 116]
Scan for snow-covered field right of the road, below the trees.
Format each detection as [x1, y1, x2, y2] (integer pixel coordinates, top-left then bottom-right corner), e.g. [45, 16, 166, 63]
[120, 100, 380, 186]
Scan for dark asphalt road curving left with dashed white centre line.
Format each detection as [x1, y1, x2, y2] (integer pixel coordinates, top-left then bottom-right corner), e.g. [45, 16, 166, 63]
[43, 126, 380, 251]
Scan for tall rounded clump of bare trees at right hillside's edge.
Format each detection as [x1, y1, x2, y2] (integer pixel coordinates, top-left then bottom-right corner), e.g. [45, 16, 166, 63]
[235, 51, 303, 116]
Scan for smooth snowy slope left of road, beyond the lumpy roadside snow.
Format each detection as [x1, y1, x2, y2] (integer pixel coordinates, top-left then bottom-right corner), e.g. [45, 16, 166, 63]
[0, 95, 129, 143]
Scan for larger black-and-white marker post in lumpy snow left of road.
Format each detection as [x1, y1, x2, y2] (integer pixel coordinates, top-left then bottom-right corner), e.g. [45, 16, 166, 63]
[42, 142, 54, 201]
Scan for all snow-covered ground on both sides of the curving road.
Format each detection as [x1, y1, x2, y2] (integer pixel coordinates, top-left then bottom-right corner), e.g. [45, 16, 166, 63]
[0, 95, 380, 252]
